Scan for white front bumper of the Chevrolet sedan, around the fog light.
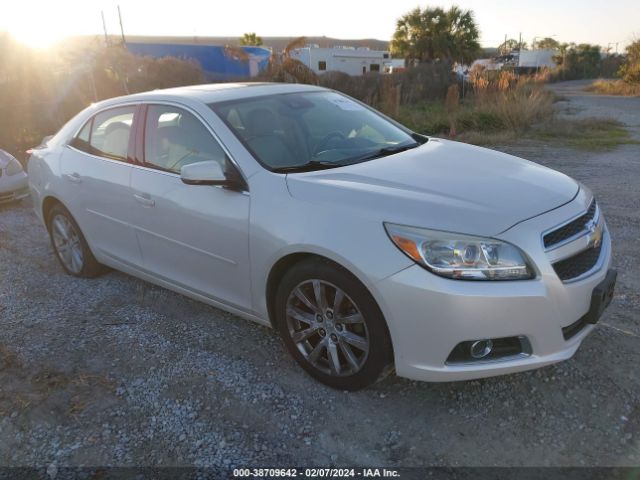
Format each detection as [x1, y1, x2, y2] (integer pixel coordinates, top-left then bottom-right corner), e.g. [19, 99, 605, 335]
[376, 191, 611, 382]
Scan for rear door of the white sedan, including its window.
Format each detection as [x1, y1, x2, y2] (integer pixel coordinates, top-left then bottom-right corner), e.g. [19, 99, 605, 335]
[60, 105, 142, 266]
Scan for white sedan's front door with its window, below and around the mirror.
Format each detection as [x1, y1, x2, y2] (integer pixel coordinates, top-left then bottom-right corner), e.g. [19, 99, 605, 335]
[131, 104, 251, 310]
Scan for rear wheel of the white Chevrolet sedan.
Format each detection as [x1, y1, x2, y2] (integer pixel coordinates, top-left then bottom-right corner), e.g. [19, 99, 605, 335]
[47, 204, 104, 278]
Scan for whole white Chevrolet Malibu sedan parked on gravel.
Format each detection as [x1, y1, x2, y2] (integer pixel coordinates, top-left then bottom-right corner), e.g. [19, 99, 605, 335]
[28, 84, 616, 389]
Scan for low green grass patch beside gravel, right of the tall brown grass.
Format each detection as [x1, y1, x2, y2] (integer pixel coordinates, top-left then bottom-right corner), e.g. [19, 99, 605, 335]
[530, 118, 640, 151]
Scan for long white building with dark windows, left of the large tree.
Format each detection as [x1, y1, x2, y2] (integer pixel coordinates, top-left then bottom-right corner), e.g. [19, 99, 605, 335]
[290, 45, 404, 75]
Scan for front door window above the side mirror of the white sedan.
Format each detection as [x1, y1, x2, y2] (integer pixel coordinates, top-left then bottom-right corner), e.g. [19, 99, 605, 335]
[144, 105, 228, 173]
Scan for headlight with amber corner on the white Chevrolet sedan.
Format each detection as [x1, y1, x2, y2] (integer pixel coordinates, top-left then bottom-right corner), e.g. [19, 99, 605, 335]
[384, 223, 534, 280]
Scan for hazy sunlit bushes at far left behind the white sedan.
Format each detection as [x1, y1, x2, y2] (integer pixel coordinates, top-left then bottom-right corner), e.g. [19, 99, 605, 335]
[0, 33, 205, 158]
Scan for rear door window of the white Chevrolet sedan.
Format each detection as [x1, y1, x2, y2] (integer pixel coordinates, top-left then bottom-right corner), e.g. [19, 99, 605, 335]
[72, 106, 136, 161]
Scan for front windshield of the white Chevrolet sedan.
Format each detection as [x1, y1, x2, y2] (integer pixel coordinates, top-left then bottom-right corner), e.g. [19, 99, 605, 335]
[210, 91, 418, 172]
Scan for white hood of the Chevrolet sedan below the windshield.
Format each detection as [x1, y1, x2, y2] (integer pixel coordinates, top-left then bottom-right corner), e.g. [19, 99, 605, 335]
[287, 139, 580, 235]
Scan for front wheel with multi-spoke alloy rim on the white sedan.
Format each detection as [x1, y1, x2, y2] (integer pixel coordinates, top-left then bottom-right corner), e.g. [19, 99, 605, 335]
[275, 258, 393, 390]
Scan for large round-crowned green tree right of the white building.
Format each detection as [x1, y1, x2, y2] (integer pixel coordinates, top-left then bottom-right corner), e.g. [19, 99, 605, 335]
[391, 6, 480, 63]
